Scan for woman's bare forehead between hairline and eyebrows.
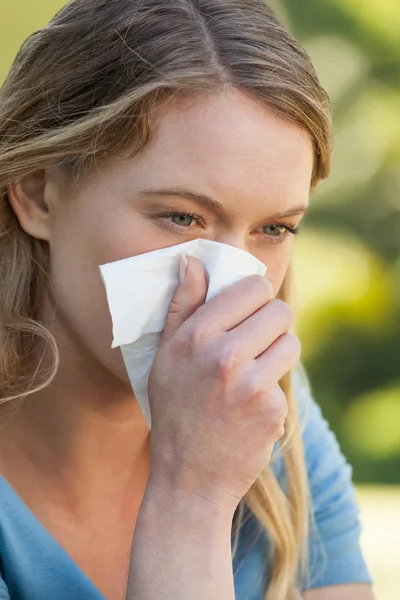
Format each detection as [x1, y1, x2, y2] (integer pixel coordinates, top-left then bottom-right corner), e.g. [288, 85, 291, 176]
[95, 91, 314, 211]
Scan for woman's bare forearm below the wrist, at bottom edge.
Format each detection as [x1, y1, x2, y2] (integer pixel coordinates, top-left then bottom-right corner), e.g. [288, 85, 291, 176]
[126, 484, 235, 600]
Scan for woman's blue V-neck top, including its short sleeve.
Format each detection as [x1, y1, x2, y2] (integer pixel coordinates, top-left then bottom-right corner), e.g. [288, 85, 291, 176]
[0, 370, 371, 600]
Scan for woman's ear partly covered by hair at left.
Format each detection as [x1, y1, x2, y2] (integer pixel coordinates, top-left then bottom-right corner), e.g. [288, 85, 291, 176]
[8, 171, 50, 242]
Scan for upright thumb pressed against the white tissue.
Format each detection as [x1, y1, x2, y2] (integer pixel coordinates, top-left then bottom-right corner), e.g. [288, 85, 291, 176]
[161, 254, 208, 342]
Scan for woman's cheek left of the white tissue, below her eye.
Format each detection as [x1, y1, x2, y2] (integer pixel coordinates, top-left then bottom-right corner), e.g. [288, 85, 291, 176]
[44, 195, 178, 383]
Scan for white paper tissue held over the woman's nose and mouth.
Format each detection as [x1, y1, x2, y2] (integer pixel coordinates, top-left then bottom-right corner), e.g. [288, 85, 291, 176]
[100, 239, 266, 427]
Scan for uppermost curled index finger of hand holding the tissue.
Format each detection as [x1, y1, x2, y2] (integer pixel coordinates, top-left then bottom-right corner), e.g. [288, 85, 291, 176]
[183, 275, 273, 334]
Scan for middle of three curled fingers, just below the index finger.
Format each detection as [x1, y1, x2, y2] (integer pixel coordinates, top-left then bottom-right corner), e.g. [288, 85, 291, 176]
[226, 300, 293, 360]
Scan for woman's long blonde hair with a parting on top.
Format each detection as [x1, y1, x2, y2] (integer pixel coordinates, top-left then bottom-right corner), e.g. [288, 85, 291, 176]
[0, 0, 331, 600]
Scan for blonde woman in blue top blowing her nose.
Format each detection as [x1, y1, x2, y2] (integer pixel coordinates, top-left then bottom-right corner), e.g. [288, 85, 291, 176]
[0, 0, 372, 600]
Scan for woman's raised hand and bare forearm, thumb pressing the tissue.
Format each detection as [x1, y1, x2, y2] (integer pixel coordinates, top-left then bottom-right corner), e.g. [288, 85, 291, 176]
[127, 257, 300, 600]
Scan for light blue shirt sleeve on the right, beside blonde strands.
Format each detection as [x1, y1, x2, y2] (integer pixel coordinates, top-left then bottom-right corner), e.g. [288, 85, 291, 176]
[294, 368, 371, 589]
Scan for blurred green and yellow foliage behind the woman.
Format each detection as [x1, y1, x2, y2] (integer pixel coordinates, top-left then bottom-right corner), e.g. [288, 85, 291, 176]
[0, 0, 400, 483]
